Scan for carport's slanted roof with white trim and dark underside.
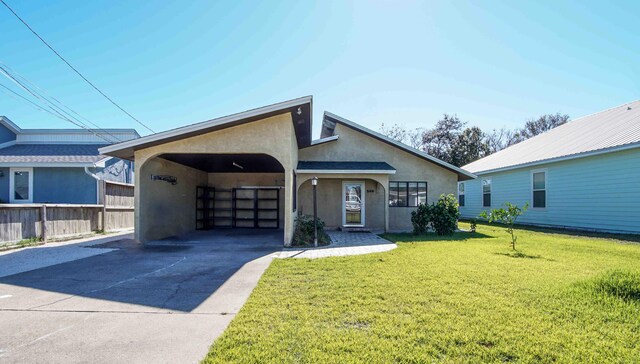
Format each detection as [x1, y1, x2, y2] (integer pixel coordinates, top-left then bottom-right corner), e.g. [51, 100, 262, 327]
[100, 96, 313, 159]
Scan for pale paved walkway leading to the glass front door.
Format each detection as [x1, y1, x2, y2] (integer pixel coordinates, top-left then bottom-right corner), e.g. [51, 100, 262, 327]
[277, 230, 398, 259]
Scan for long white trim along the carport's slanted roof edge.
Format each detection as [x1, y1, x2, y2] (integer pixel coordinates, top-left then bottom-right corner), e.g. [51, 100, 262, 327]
[99, 96, 312, 154]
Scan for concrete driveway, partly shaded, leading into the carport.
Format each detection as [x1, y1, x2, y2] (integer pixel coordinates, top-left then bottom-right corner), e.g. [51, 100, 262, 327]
[0, 230, 282, 363]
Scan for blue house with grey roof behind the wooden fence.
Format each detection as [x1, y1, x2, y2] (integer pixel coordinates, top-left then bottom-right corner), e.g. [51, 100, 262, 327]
[0, 116, 140, 204]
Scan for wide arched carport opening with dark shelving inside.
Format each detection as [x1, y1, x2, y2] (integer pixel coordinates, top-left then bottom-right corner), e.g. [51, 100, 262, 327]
[136, 153, 285, 242]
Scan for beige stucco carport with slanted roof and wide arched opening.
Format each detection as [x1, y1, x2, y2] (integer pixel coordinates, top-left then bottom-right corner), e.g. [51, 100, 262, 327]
[100, 97, 311, 245]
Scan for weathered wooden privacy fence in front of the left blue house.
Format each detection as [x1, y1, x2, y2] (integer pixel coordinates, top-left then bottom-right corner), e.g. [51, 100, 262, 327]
[0, 181, 134, 243]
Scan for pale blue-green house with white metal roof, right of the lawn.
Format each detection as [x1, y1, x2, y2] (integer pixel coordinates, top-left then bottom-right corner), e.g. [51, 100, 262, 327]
[458, 101, 640, 233]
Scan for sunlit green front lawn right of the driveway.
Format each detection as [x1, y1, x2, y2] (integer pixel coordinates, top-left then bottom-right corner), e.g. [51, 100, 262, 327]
[204, 224, 640, 363]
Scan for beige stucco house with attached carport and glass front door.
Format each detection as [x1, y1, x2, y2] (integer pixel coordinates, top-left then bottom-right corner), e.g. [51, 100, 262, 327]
[100, 96, 474, 245]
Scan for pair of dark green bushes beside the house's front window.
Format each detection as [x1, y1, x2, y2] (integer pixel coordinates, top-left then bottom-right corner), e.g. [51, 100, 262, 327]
[411, 194, 460, 235]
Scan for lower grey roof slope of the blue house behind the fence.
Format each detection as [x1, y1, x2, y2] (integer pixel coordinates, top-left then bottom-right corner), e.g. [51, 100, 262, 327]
[0, 144, 107, 165]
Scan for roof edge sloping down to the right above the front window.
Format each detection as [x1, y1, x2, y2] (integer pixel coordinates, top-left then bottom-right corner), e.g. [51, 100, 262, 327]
[320, 111, 476, 180]
